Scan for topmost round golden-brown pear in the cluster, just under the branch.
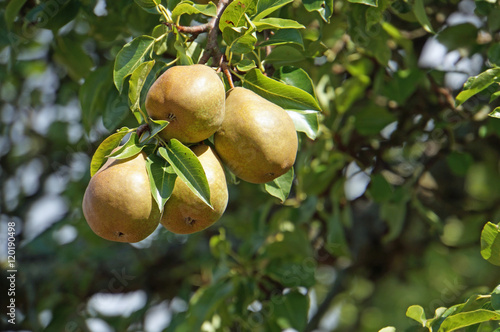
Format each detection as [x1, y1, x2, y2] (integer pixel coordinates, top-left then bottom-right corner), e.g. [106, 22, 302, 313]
[145, 64, 226, 143]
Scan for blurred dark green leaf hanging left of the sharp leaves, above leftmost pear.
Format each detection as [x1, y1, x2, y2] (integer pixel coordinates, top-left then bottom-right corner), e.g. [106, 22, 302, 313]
[78, 67, 111, 131]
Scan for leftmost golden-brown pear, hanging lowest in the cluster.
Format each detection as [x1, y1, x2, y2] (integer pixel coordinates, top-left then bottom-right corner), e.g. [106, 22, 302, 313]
[83, 152, 161, 242]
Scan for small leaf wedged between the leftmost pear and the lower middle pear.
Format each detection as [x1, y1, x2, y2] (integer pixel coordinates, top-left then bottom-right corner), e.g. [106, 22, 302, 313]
[146, 154, 177, 212]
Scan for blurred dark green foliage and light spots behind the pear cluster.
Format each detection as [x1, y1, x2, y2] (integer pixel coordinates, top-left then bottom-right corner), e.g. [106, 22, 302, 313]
[0, 0, 500, 331]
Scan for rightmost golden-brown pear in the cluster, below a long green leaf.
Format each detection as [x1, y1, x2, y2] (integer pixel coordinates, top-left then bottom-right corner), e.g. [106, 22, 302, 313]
[214, 87, 298, 183]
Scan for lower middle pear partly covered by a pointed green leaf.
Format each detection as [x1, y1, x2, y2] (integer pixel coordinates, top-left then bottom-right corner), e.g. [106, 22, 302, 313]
[161, 145, 228, 234]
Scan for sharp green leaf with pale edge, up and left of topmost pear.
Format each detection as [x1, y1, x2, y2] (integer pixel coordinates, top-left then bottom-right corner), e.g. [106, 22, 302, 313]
[113, 36, 155, 93]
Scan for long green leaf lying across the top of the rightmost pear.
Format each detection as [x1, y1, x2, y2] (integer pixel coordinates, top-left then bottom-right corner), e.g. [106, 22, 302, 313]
[243, 69, 321, 111]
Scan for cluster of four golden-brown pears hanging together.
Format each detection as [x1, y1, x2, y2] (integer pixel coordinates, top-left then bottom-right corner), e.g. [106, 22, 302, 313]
[83, 64, 298, 242]
